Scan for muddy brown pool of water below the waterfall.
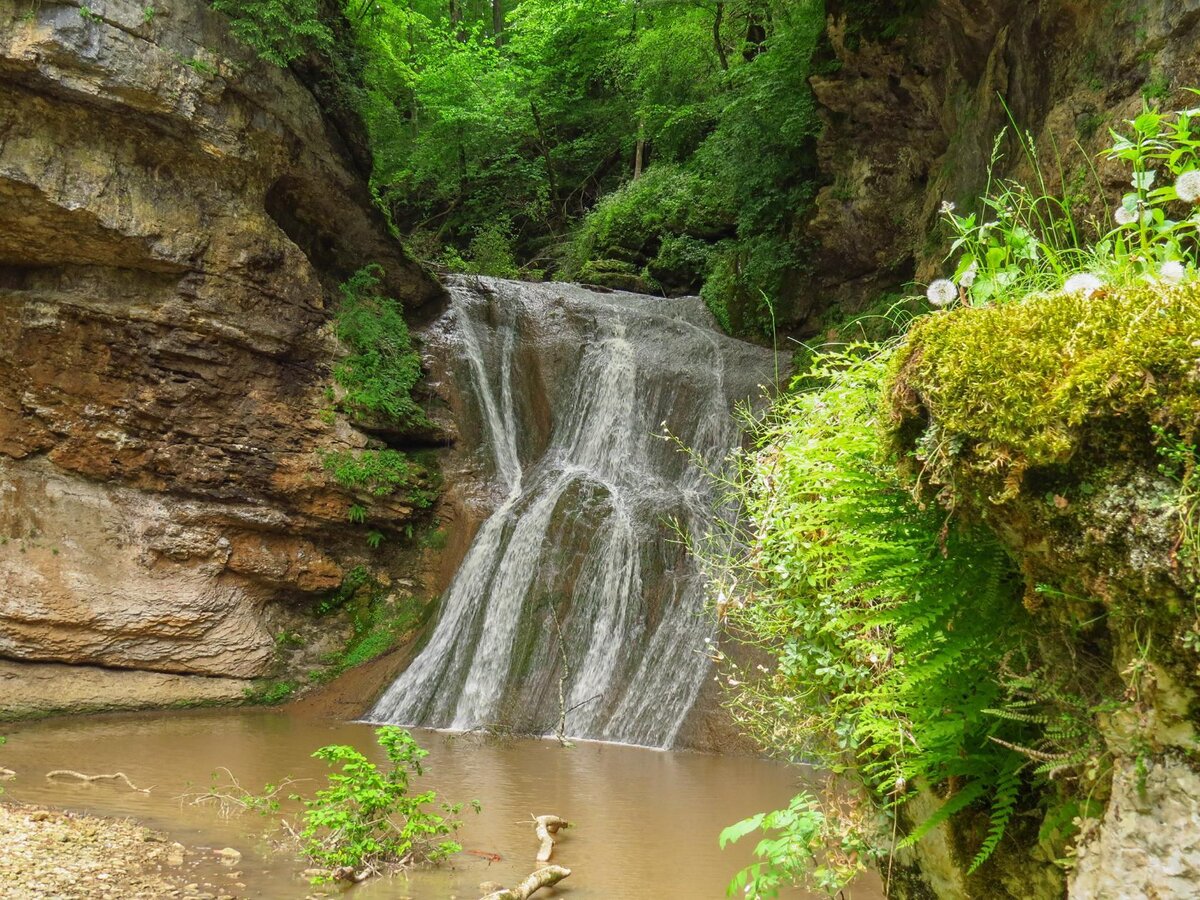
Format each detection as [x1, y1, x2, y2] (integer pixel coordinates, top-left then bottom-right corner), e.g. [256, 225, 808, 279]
[0, 710, 882, 900]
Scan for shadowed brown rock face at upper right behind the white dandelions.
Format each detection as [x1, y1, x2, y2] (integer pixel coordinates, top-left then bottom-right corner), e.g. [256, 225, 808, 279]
[798, 0, 1200, 313]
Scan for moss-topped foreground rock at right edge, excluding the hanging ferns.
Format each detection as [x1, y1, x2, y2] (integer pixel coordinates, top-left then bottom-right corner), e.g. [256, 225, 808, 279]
[884, 284, 1200, 896]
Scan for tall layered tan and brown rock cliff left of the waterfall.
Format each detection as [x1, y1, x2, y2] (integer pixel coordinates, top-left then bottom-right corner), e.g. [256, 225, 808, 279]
[0, 0, 440, 714]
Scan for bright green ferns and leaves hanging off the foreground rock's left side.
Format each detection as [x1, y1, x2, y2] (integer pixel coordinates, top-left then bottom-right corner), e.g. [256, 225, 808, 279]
[705, 347, 1067, 883]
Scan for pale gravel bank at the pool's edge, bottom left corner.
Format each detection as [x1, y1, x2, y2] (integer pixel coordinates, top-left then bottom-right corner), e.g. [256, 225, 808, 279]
[0, 803, 245, 900]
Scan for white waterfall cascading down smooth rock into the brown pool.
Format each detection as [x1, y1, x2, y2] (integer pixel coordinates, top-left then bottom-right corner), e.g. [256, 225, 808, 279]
[368, 280, 769, 746]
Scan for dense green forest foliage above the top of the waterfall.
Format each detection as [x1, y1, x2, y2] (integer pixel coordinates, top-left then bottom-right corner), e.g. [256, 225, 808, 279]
[214, 0, 835, 332]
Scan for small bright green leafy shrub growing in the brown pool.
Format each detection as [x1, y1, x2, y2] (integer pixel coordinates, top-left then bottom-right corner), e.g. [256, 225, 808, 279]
[293, 726, 478, 871]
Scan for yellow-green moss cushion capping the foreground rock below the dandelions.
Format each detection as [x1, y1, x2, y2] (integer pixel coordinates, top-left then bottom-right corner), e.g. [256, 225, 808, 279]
[887, 284, 1200, 473]
